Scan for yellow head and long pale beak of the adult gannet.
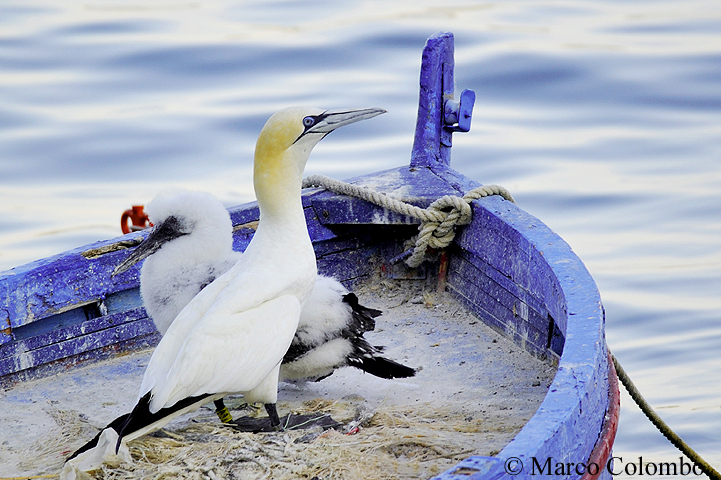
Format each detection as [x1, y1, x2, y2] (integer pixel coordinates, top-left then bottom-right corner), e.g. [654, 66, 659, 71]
[253, 107, 385, 217]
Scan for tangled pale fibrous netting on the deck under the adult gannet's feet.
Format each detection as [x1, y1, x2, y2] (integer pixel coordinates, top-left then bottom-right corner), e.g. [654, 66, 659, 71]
[83, 399, 523, 480]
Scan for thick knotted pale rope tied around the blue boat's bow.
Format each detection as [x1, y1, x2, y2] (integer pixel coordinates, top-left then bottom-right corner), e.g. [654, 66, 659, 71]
[303, 175, 515, 268]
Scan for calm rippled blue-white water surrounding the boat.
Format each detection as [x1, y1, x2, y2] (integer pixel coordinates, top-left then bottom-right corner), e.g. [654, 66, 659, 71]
[0, 0, 721, 478]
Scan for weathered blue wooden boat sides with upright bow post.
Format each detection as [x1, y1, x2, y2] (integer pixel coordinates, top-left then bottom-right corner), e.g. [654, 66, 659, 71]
[0, 33, 619, 480]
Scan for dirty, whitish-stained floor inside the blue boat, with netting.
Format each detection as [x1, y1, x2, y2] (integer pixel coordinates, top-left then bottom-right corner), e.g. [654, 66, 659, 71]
[0, 280, 556, 478]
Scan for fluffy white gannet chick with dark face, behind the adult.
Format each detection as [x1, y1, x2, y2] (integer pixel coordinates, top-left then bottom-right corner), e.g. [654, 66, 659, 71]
[68, 166, 422, 476]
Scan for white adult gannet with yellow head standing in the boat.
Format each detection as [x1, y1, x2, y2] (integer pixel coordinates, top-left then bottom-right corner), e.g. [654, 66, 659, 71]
[110, 107, 385, 447]
